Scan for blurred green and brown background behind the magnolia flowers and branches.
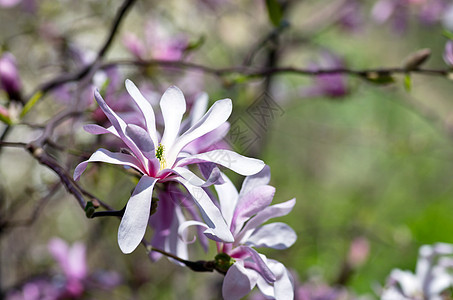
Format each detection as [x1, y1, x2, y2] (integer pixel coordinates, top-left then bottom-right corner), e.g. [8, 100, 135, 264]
[0, 0, 453, 299]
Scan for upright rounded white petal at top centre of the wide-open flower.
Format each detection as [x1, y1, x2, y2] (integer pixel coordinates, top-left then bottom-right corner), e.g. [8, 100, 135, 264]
[160, 86, 186, 152]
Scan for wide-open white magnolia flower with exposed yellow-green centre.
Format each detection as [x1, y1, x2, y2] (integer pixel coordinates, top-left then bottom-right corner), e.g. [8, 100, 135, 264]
[74, 80, 264, 253]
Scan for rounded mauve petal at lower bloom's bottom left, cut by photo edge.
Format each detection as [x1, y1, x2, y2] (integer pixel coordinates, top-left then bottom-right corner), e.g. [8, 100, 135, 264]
[222, 261, 258, 300]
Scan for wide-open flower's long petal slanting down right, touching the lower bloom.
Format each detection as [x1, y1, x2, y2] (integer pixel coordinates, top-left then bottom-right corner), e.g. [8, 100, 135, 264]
[178, 178, 234, 243]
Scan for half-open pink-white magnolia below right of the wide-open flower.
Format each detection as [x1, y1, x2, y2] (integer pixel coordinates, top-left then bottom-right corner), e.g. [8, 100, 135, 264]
[184, 167, 297, 300]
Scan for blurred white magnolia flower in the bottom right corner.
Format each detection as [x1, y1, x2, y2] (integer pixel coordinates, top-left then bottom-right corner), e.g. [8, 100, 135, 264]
[381, 243, 453, 300]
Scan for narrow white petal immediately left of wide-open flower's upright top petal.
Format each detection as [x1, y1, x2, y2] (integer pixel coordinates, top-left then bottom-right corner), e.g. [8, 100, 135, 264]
[125, 79, 159, 147]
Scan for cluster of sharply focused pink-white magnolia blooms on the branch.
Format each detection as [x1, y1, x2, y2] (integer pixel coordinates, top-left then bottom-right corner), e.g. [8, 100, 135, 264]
[74, 80, 297, 299]
